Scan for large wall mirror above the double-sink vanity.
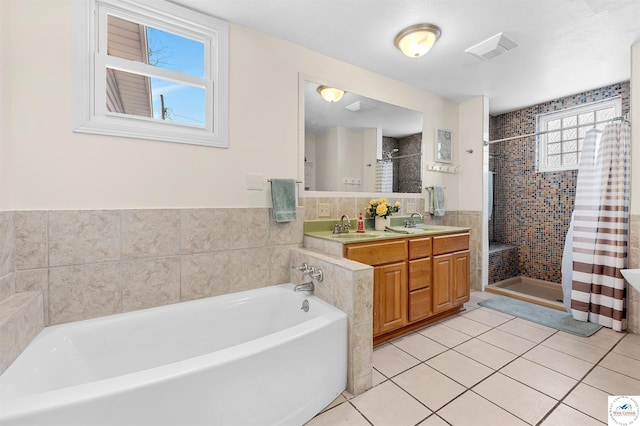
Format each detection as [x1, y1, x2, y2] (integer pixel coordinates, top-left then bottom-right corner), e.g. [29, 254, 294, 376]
[304, 81, 422, 193]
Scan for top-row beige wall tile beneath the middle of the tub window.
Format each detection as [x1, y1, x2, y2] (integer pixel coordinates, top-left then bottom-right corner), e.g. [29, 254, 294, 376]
[122, 210, 180, 259]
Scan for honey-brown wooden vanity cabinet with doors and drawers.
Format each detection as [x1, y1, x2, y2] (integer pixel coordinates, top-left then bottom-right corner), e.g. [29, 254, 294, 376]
[344, 232, 470, 344]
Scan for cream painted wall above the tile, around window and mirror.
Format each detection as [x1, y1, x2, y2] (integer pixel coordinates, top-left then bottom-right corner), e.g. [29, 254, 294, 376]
[0, 0, 457, 210]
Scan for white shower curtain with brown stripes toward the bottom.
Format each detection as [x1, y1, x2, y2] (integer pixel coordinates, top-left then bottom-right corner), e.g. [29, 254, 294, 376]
[571, 122, 631, 331]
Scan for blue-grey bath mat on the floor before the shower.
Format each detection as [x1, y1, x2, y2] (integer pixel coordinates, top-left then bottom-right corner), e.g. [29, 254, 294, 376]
[478, 296, 602, 337]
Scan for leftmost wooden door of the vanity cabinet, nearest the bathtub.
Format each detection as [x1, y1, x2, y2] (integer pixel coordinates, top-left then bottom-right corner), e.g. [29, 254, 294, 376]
[373, 262, 408, 336]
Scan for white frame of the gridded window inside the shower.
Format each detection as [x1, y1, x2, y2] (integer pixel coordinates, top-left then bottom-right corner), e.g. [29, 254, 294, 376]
[536, 96, 622, 173]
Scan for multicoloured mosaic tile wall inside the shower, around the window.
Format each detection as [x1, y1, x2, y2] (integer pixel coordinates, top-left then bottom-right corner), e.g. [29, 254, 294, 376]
[489, 82, 629, 283]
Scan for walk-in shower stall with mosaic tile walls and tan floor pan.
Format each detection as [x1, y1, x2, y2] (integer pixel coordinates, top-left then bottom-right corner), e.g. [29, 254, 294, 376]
[485, 82, 629, 311]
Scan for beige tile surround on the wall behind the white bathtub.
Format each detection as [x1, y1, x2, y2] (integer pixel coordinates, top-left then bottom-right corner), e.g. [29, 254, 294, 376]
[5, 208, 304, 325]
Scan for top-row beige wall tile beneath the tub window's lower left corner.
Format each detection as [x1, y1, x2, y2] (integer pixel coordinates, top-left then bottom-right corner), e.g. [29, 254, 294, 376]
[49, 210, 120, 266]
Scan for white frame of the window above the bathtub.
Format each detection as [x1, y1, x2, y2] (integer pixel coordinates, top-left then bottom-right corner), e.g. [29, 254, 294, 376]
[72, 0, 229, 148]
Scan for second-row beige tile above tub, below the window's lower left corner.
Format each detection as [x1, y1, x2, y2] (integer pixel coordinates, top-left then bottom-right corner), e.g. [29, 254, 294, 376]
[49, 262, 121, 324]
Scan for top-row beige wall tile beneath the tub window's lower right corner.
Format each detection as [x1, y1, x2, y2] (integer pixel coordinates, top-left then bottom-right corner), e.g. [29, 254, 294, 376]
[181, 209, 234, 254]
